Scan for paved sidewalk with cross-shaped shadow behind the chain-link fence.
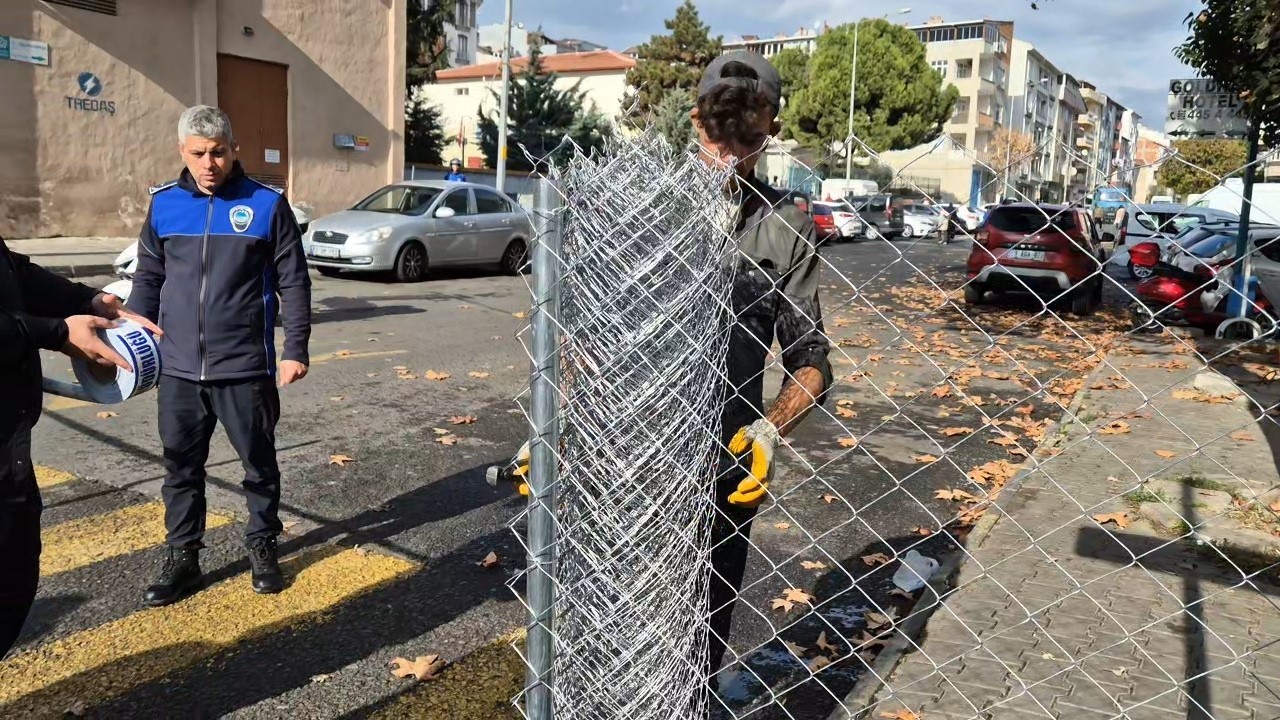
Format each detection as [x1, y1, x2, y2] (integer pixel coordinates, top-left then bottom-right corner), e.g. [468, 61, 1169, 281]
[867, 336, 1280, 720]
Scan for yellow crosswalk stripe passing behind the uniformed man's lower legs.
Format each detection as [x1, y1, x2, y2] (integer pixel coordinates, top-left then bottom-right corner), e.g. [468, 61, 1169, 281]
[40, 501, 232, 578]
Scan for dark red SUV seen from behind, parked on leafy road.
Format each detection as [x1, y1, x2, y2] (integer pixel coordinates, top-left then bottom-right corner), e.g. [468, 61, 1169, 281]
[964, 202, 1106, 315]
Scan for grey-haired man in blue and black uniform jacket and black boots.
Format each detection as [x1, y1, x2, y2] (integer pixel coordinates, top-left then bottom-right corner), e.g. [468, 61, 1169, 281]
[129, 105, 311, 606]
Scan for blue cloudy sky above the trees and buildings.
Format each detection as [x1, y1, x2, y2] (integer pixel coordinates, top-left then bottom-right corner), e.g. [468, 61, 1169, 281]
[480, 0, 1201, 128]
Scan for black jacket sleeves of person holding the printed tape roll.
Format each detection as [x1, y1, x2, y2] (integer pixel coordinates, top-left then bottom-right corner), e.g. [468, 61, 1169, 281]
[0, 251, 97, 365]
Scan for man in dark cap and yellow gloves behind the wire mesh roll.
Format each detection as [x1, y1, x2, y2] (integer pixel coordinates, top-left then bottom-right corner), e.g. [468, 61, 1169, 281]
[692, 53, 832, 687]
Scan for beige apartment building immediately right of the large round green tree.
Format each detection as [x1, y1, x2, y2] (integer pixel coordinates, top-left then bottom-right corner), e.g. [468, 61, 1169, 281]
[881, 17, 1014, 202]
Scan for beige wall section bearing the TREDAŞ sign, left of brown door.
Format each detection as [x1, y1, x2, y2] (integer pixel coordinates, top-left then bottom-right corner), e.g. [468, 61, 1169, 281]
[0, 0, 195, 237]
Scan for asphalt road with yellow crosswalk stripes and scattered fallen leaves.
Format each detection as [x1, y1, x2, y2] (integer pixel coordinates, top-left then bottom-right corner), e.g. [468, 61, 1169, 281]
[10, 241, 1131, 717]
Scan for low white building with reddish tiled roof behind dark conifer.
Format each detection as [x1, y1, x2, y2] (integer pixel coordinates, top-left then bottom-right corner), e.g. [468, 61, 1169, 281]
[417, 50, 636, 168]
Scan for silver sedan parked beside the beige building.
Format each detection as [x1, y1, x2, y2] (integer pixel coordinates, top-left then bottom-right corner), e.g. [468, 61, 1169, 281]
[302, 181, 532, 282]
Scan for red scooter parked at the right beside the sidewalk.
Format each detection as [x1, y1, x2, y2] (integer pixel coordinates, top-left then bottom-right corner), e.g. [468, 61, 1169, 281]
[1129, 242, 1276, 336]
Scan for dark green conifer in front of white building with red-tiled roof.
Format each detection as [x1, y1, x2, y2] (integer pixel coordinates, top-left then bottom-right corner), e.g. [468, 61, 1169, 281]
[477, 45, 612, 170]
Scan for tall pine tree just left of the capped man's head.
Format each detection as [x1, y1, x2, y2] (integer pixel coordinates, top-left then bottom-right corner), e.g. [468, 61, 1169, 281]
[627, 0, 723, 120]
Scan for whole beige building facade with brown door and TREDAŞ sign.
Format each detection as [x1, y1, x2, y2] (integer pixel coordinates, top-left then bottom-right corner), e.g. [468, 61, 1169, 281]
[0, 0, 404, 237]
